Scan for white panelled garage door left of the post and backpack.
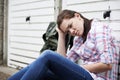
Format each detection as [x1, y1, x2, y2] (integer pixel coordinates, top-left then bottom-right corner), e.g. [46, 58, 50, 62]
[8, 0, 54, 67]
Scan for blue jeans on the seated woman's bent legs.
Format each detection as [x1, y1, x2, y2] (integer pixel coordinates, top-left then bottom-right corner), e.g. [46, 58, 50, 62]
[8, 50, 93, 80]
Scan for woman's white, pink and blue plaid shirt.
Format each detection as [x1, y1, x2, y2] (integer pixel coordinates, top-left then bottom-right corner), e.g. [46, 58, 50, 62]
[67, 19, 119, 80]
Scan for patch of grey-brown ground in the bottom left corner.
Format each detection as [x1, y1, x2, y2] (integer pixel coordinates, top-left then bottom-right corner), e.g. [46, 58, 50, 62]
[0, 65, 18, 80]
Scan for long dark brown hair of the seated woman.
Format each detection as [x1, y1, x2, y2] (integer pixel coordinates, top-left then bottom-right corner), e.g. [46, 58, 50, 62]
[57, 10, 92, 43]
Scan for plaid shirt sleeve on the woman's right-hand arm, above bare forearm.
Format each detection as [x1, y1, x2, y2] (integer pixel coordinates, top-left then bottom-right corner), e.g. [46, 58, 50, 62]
[95, 24, 114, 64]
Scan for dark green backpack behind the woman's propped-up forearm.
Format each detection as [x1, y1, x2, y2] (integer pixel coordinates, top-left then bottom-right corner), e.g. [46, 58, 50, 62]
[40, 22, 74, 53]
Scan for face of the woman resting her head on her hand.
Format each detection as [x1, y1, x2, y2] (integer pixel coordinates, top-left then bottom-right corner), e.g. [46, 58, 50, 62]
[60, 13, 84, 36]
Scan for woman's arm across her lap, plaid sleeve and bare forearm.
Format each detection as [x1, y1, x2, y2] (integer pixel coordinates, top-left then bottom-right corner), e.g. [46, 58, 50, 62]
[83, 23, 114, 73]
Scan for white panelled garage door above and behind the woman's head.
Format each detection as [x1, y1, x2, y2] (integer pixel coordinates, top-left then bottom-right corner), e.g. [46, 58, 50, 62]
[62, 0, 120, 40]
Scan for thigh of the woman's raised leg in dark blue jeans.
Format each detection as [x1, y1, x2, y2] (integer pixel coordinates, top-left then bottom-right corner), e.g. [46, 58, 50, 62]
[46, 51, 93, 80]
